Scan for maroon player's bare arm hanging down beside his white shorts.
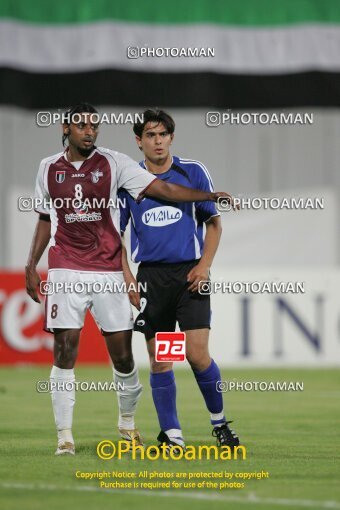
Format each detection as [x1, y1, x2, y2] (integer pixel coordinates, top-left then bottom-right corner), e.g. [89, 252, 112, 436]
[25, 219, 51, 303]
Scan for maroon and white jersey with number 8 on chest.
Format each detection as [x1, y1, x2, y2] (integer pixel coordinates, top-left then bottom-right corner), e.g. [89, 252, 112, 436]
[35, 147, 155, 272]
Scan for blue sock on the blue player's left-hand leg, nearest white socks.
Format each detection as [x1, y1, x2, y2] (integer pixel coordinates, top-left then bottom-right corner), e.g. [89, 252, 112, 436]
[150, 370, 183, 444]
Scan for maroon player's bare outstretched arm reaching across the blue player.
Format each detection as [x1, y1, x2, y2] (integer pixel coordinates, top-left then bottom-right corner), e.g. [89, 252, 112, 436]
[145, 179, 238, 205]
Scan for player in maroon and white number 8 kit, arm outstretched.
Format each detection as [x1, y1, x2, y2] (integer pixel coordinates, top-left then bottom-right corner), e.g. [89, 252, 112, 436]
[25, 103, 232, 455]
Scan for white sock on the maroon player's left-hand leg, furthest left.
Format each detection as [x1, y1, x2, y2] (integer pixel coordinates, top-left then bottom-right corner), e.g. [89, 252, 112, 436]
[50, 366, 76, 445]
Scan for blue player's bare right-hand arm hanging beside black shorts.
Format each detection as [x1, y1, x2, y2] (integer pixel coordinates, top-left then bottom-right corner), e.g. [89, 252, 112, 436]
[187, 216, 222, 292]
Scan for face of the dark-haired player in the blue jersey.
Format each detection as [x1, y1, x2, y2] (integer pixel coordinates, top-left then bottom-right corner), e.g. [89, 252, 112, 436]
[136, 122, 174, 162]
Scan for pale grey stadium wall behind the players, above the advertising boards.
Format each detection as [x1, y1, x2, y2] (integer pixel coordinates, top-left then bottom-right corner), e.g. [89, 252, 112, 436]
[0, 107, 340, 270]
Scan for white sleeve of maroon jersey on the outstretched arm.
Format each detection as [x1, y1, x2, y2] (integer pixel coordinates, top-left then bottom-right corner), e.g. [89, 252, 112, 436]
[117, 154, 157, 201]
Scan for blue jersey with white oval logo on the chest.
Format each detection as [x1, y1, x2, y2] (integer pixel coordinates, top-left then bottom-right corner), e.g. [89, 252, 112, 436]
[118, 156, 219, 263]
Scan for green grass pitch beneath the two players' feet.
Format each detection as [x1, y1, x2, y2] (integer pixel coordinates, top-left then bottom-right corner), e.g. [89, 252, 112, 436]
[0, 366, 340, 510]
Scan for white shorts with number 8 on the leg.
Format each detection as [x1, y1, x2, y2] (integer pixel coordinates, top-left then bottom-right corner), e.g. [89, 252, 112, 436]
[44, 269, 133, 333]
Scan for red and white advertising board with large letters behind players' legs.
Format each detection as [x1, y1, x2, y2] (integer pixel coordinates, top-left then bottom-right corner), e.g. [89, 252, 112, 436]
[0, 266, 340, 367]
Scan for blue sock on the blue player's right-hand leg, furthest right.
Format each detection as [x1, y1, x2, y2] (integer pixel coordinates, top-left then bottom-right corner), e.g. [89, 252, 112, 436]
[193, 359, 226, 426]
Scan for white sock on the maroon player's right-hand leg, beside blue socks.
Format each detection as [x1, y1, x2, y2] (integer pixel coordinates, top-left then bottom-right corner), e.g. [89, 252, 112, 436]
[113, 366, 143, 430]
